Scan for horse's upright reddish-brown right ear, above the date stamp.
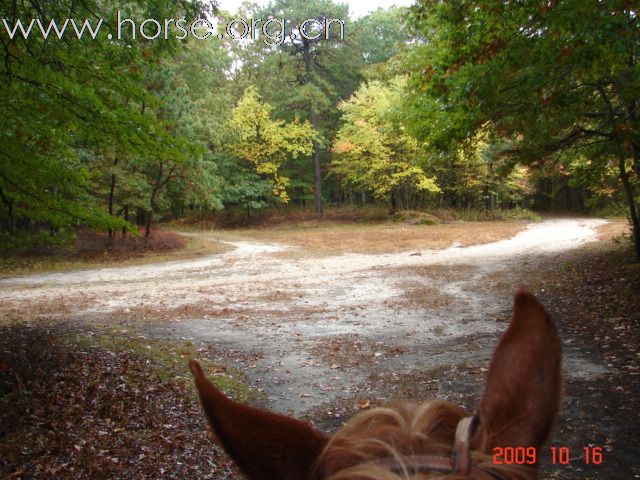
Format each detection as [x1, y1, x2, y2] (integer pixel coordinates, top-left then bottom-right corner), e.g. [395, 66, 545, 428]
[478, 290, 562, 452]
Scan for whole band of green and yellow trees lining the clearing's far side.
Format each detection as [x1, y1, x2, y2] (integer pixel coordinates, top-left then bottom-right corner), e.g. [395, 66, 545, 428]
[0, 0, 640, 258]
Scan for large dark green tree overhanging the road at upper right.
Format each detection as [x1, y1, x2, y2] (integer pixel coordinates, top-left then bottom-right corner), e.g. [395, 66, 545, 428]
[407, 0, 640, 260]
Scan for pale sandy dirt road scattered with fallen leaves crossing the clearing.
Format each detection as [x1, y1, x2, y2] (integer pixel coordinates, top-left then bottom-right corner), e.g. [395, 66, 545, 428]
[0, 219, 606, 414]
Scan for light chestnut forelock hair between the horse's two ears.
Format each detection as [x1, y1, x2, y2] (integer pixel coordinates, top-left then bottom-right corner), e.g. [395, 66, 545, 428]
[312, 400, 536, 480]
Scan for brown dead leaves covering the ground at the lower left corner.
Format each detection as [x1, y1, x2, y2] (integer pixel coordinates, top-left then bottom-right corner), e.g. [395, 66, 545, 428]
[0, 326, 240, 479]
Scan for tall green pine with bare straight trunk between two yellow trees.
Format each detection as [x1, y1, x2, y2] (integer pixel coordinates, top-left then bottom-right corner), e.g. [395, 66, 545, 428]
[249, 0, 365, 216]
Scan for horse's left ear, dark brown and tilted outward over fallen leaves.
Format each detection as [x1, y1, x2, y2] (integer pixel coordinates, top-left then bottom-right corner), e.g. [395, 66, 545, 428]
[189, 360, 327, 480]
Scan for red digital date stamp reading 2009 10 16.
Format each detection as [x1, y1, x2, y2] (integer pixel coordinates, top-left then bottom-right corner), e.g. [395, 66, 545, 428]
[493, 446, 604, 465]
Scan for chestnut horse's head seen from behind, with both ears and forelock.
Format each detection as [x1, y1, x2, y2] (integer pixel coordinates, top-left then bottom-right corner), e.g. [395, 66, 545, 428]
[189, 290, 562, 480]
